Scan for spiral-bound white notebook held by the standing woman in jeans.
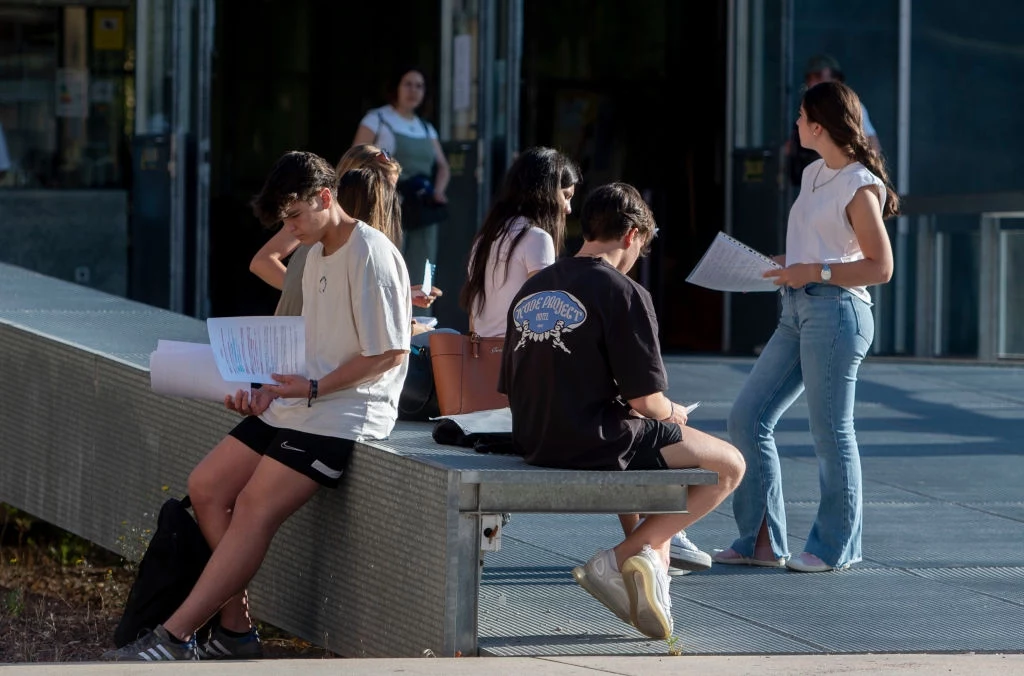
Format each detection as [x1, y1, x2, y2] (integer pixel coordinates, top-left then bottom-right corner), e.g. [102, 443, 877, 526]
[686, 233, 781, 293]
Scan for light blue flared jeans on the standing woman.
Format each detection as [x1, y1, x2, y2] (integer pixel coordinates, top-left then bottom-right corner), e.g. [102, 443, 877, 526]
[729, 284, 874, 567]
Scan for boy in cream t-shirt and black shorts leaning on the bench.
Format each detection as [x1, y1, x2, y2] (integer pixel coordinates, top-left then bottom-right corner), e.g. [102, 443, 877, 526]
[101, 152, 412, 662]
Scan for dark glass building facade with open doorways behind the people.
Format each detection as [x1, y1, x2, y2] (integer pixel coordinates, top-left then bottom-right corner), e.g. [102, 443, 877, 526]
[0, 0, 1024, 362]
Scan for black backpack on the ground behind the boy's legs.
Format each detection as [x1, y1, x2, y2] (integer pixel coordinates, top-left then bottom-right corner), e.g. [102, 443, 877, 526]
[114, 496, 210, 647]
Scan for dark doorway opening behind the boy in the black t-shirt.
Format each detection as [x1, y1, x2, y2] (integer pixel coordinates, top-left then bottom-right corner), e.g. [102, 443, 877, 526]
[521, 0, 726, 351]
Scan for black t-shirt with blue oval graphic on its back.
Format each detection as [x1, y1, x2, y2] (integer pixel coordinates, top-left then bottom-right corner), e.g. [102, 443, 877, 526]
[499, 257, 668, 469]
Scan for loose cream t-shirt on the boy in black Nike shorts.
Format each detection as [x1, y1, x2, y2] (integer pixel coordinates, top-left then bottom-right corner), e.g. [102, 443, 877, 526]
[261, 221, 413, 440]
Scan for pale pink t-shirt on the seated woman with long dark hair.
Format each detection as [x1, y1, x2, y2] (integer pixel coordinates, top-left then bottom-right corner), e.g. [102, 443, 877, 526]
[471, 216, 555, 338]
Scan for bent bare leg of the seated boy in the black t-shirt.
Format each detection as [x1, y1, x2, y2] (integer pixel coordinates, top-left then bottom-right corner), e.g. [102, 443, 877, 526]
[614, 426, 745, 569]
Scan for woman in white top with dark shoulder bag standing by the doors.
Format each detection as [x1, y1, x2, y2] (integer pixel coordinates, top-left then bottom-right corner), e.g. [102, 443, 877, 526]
[352, 67, 451, 294]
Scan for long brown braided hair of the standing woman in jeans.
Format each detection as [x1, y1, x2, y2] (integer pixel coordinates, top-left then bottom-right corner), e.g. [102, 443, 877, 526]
[802, 80, 899, 218]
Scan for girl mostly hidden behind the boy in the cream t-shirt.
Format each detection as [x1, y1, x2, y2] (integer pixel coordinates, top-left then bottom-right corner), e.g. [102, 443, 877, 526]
[249, 143, 442, 327]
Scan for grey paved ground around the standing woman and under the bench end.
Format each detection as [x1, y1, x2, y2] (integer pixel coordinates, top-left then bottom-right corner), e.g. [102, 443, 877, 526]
[3, 357, 1024, 676]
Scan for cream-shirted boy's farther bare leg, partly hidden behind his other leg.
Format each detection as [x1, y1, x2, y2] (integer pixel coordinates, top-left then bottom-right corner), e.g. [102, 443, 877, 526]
[188, 436, 262, 632]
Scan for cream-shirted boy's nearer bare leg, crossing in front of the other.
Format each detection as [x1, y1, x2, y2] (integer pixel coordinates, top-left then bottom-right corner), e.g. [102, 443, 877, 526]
[164, 457, 319, 640]
